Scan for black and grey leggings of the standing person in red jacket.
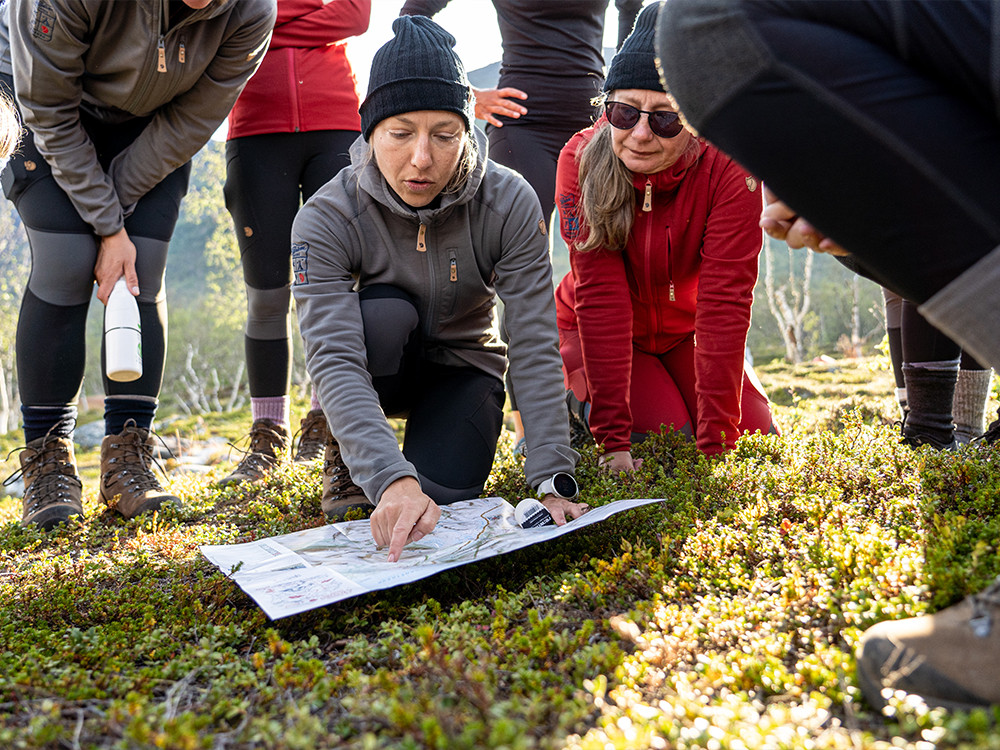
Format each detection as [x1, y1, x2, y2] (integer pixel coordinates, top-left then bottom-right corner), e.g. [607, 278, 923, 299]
[224, 130, 358, 398]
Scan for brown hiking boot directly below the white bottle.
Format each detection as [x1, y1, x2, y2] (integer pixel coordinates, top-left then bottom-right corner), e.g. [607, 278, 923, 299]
[101, 420, 181, 518]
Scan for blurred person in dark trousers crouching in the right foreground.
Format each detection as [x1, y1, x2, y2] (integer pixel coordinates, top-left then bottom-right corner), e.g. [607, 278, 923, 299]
[657, 0, 1000, 710]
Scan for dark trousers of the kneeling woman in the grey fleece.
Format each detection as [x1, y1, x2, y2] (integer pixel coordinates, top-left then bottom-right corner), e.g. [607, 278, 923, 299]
[360, 285, 504, 505]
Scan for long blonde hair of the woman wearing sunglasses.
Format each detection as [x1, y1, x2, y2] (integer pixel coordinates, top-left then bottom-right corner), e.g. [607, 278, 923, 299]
[574, 123, 635, 252]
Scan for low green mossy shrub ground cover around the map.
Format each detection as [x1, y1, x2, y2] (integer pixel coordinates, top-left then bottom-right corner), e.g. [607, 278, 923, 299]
[0, 360, 1000, 750]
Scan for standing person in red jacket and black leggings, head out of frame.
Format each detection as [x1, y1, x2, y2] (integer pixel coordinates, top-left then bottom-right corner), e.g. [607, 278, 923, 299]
[221, 0, 371, 484]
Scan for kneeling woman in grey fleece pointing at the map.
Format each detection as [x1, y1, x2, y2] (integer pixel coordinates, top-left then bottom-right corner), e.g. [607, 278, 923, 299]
[292, 16, 586, 561]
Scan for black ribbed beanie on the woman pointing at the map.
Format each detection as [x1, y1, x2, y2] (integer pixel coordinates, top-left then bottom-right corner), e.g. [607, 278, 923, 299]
[360, 16, 472, 141]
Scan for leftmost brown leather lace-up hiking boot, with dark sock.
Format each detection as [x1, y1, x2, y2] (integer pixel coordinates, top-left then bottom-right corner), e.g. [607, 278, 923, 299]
[11, 435, 83, 531]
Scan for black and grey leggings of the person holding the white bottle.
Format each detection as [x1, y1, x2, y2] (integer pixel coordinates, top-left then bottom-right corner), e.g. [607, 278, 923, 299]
[0, 76, 191, 407]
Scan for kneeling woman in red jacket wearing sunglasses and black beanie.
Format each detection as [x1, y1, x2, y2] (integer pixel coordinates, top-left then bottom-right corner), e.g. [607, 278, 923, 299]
[556, 6, 775, 470]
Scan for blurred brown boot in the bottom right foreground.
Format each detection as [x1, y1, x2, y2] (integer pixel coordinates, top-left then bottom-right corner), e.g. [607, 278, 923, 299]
[858, 578, 1000, 711]
